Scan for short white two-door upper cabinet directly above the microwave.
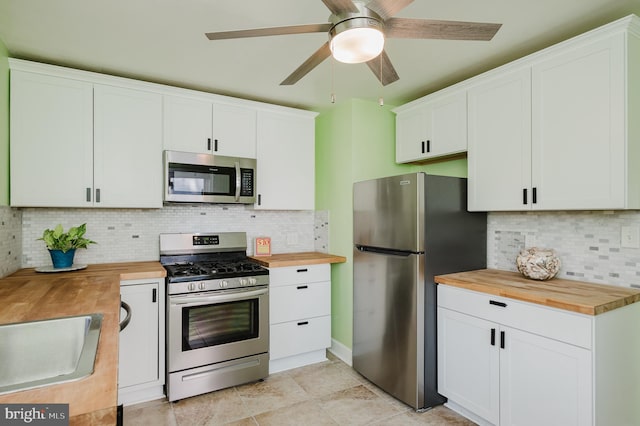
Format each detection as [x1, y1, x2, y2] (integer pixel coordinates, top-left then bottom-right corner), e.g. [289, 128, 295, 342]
[164, 95, 256, 158]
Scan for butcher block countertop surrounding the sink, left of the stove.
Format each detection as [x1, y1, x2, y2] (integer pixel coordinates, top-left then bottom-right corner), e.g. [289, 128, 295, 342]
[0, 262, 166, 426]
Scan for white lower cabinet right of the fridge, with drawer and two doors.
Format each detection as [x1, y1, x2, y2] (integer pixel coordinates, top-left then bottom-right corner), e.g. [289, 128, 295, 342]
[438, 285, 640, 426]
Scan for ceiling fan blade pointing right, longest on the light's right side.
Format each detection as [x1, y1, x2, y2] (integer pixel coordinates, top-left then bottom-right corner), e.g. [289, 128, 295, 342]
[384, 18, 502, 41]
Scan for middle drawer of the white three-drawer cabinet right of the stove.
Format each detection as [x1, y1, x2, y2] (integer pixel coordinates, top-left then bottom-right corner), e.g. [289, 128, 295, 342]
[269, 281, 331, 324]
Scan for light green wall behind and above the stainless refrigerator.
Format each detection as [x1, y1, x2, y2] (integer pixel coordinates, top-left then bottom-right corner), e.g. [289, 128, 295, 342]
[316, 99, 467, 348]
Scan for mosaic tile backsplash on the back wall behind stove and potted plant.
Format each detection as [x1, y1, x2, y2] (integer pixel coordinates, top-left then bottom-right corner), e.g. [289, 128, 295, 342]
[20, 204, 329, 268]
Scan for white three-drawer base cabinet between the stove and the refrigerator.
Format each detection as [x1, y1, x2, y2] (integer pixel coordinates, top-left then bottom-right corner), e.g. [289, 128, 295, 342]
[269, 264, 331, 373]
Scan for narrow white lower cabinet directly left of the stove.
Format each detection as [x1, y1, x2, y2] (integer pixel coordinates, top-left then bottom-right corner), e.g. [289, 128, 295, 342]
[118, 278, 165, 405]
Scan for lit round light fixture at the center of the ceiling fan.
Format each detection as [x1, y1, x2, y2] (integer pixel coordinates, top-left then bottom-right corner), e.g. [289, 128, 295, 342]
[329, 18, 384, 64]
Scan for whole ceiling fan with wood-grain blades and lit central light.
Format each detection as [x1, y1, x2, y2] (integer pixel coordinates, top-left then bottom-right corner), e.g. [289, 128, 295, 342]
[205, 0, 502, 86]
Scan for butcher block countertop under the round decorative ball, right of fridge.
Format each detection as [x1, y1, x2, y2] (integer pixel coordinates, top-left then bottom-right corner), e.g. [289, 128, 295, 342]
[435, 269, 640, 315]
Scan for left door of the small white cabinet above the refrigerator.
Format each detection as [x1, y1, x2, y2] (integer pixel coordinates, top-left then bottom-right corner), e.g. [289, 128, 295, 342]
[396, 104, 431, 163]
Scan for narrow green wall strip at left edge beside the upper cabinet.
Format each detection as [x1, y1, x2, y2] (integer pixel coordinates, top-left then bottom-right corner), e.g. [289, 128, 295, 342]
[0, 40, 9, 206]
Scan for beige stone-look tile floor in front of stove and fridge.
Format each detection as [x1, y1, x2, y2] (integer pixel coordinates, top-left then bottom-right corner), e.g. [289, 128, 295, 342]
[124, 354, 475, 426]
